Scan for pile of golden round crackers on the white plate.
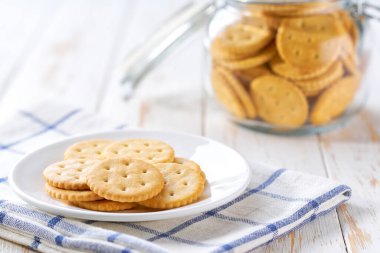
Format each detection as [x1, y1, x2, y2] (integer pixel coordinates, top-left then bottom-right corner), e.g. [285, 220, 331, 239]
[43, 139, 206, 211]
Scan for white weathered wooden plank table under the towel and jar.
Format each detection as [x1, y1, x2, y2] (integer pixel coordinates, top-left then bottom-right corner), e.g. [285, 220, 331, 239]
[0, 0, 380, 253]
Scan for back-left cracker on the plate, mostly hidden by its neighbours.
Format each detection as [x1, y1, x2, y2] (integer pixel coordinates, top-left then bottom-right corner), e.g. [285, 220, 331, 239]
[64, 140, 112, 159]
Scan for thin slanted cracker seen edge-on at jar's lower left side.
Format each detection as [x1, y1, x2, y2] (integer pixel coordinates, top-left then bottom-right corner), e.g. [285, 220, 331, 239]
[214, 67, 256, 118]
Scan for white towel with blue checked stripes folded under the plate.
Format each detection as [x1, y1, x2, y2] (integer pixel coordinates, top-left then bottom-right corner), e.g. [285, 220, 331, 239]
[0, 102, 351, 252]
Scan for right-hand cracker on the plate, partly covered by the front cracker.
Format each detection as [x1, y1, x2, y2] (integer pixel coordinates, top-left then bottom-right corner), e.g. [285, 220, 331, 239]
[139, 163, 205, 209]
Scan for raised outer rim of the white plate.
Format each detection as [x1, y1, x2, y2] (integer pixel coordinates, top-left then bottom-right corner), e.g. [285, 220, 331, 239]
[8, 128, 252, 222]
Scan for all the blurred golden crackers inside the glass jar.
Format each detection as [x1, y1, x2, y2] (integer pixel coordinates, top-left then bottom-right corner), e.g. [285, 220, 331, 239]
[210, 1, 360, 128]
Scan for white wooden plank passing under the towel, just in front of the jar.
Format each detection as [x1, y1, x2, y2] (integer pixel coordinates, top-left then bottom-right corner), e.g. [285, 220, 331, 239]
[205, 96, 346, 252]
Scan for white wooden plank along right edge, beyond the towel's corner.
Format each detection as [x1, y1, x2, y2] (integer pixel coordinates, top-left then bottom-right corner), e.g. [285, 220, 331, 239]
[320, 34, 380, 253]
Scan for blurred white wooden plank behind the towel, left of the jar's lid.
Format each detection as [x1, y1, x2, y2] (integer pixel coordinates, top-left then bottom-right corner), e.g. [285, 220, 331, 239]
[0, 0, 131, 116]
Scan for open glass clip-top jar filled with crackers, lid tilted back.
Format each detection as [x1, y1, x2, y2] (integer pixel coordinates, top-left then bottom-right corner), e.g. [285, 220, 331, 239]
[120, 0, 380, 134]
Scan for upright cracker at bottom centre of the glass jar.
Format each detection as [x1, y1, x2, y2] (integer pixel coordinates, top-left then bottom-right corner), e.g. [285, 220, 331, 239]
[251, 75, 308, 127]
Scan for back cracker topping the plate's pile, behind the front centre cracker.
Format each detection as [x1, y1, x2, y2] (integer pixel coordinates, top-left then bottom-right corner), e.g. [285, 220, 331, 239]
[104, 139, 174, 163]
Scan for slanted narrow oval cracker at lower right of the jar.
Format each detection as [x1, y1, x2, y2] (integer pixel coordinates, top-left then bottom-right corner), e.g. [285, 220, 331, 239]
[310, 76, 359, 125]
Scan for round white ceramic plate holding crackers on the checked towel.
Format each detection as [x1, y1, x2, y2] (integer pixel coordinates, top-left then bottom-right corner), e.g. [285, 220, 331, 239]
[9, 129, 251, 222]
